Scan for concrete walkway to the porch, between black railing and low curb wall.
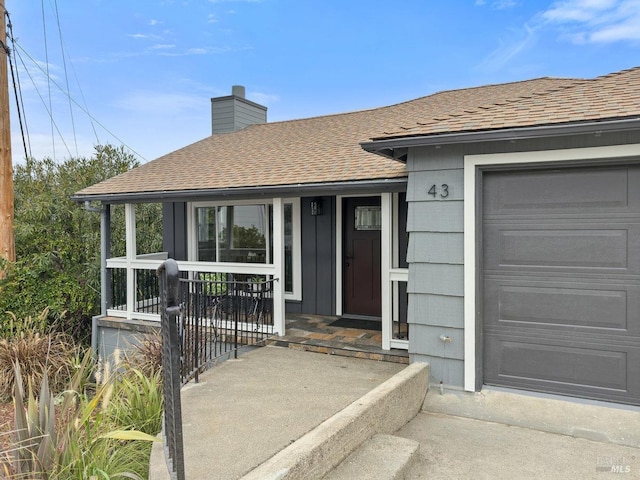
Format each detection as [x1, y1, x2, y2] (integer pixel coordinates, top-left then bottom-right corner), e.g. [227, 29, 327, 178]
[149, 347, 406, 480]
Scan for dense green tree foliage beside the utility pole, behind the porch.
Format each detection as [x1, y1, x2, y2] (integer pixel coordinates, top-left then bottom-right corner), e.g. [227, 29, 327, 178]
[0, 145, 162, 338]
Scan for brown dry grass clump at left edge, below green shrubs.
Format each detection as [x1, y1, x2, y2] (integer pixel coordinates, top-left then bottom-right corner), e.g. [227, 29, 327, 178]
[0, 332, 79, 402]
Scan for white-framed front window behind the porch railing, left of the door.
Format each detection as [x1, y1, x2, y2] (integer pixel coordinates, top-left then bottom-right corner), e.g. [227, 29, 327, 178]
[188, 198, 302, 300]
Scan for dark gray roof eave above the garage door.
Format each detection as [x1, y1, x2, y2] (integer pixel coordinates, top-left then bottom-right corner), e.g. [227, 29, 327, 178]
[360, 117, 640, 162]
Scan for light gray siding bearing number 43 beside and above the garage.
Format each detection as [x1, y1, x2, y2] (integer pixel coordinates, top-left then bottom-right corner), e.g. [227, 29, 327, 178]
[407, 132, 640, 388]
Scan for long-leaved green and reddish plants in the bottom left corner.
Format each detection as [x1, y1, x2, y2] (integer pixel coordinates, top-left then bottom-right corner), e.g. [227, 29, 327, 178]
[0, 351, 161, 480]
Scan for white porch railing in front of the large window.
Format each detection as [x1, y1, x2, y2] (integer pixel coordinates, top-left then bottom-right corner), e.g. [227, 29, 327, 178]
[107, 252, 285, 334]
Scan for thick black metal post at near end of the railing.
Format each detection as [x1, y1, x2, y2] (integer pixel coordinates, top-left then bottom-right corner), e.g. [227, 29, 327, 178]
[158, 259, 185, 480]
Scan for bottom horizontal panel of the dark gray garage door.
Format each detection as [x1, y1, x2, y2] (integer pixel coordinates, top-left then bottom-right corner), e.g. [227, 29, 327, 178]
[485, 337, 640, 403]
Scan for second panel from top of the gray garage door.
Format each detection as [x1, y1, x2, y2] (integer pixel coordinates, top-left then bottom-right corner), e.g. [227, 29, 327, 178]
[484, 224, 640, 275]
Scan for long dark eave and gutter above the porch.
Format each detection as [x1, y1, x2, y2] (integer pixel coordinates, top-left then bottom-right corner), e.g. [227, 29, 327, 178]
[71, 176, 407, 204]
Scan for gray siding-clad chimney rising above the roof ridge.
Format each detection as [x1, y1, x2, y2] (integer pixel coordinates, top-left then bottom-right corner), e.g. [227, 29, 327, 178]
[211, 85, 267, 135]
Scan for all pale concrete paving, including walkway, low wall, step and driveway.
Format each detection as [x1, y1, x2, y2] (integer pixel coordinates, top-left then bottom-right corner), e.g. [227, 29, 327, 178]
[149, 347, 640, 480]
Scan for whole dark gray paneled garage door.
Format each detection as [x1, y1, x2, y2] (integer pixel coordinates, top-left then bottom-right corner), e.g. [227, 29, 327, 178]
[481, 165, 640, 405]
